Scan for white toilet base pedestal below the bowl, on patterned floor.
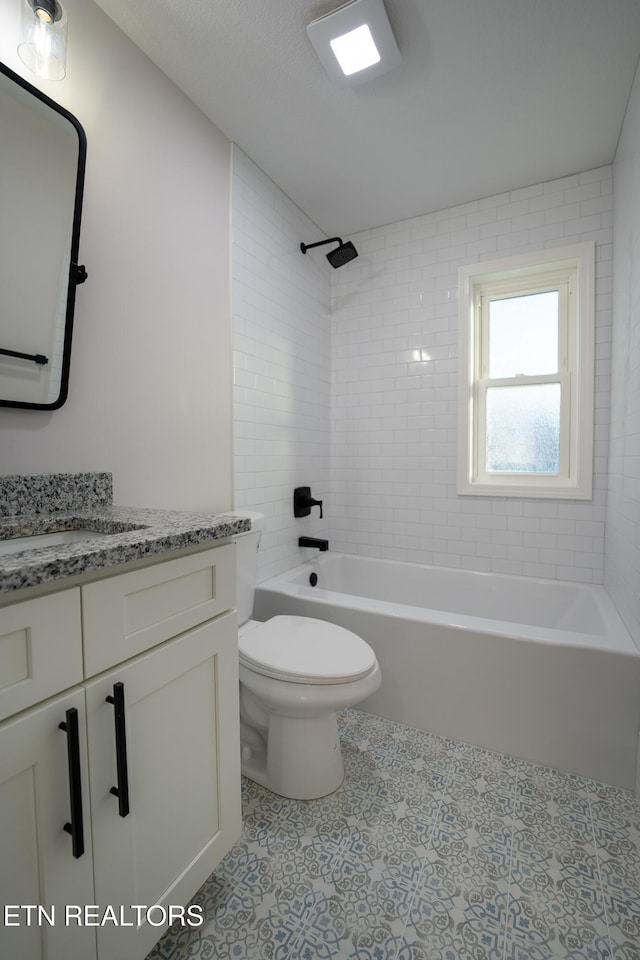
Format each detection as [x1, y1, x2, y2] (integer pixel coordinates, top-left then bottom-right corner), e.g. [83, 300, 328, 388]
[241, 693, 344, 800]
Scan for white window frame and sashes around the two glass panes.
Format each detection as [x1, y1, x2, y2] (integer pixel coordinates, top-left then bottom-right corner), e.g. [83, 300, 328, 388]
[457, 242, 595, 500]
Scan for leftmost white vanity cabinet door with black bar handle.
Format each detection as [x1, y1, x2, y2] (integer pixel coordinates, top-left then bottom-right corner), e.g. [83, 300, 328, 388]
[0, 688, 96, 960]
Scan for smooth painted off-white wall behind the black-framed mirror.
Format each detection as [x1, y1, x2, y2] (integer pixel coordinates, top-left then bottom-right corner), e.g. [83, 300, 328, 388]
[0, 0, 232, 510]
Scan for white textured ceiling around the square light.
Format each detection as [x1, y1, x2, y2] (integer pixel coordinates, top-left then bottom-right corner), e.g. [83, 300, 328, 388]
[97, 0, 640, 236]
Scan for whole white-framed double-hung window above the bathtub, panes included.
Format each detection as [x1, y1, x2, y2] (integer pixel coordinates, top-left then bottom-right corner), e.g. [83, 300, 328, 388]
[458, 243, 594, 499]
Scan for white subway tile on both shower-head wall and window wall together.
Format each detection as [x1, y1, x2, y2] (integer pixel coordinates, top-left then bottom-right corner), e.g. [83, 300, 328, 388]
[233, 148, 613, 583]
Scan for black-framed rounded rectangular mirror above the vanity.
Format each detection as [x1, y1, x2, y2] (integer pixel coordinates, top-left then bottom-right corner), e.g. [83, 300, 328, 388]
[0, 63, 87, 410]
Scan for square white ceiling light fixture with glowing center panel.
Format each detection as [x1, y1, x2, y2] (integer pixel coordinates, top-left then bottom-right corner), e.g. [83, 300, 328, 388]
[307, 0, 400, 86]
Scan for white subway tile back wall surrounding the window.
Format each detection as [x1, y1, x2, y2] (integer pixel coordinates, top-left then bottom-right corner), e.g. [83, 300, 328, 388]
[331, 167, 613, 583]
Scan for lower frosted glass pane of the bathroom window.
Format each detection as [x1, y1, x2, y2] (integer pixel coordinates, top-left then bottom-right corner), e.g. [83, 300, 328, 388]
[486, 383, 560, 474]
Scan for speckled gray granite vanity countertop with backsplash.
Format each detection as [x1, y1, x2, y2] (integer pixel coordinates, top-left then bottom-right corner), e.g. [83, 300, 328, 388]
[0, 474, 251, 600]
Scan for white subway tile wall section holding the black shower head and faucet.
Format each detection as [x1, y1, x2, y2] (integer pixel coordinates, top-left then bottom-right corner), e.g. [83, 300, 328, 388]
[232, 147, 331, 580]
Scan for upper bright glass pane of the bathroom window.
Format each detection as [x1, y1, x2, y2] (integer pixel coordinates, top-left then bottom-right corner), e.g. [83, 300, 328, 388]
[489, 290, 559, 379]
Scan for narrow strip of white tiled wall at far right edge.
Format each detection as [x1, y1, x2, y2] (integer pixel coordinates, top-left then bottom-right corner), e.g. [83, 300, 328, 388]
[605, 60, 640, 645]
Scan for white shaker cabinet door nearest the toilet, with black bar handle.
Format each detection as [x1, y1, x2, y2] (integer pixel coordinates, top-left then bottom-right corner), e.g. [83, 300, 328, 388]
[86, 611, 241, 960]
